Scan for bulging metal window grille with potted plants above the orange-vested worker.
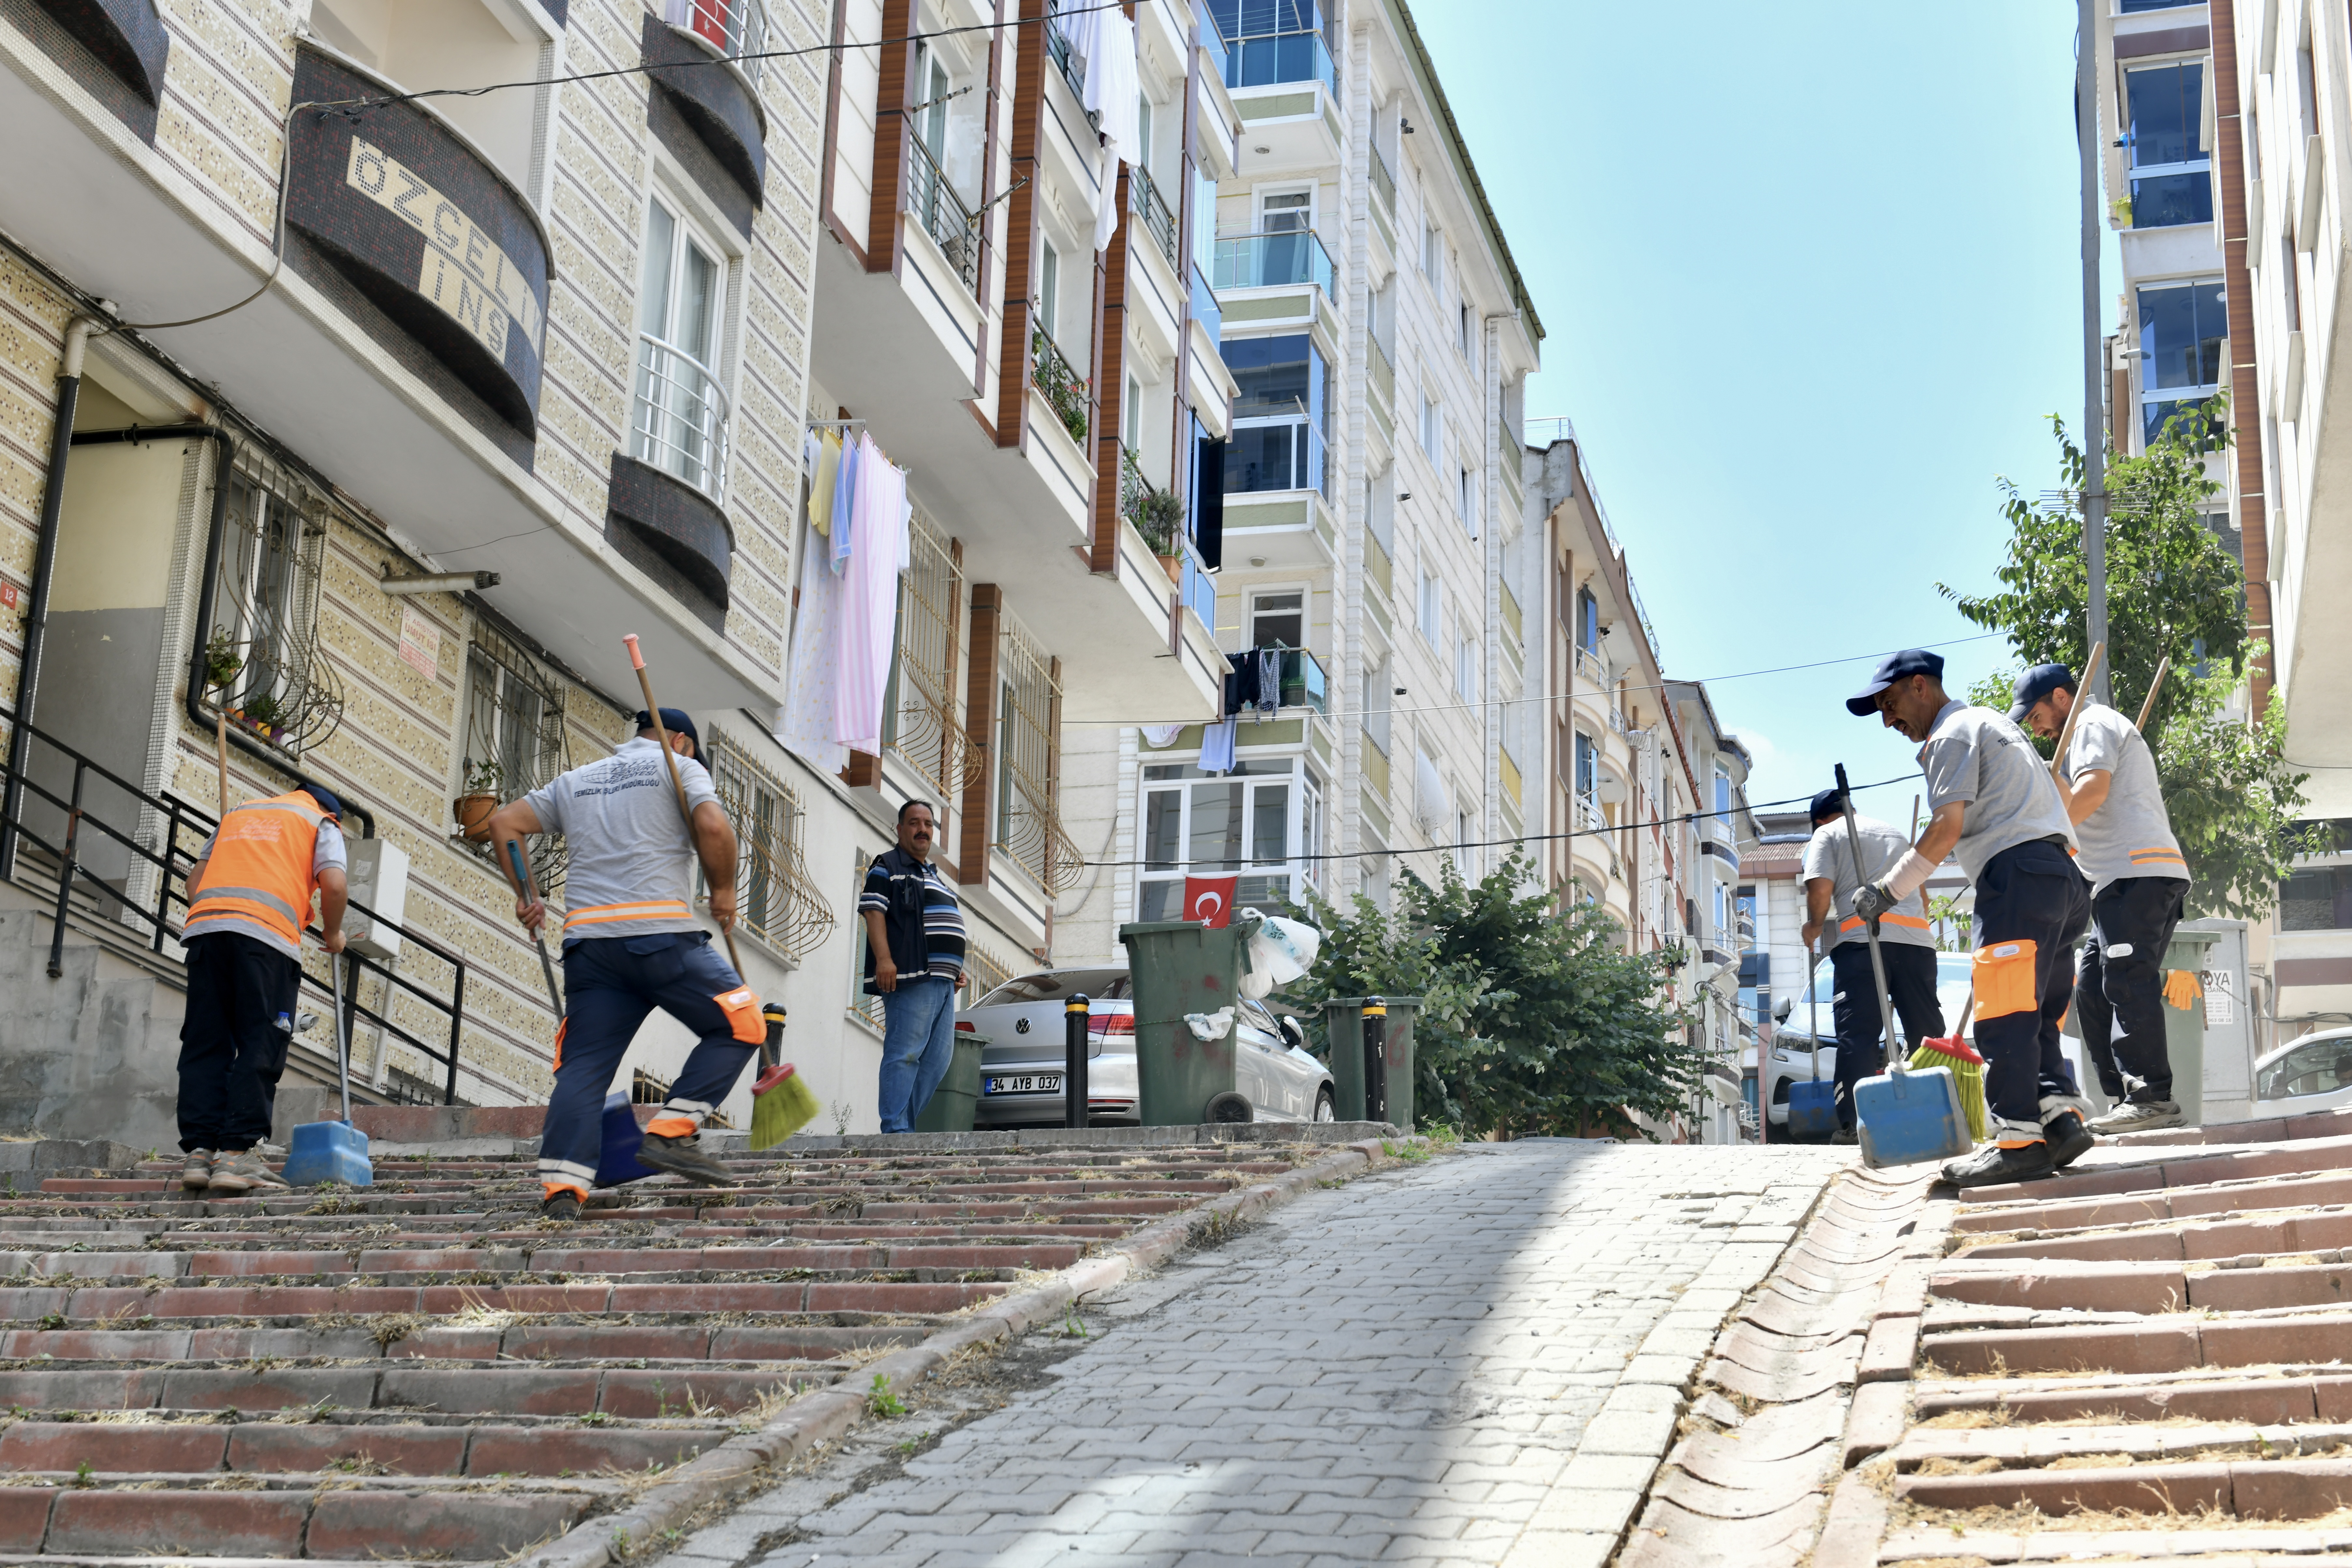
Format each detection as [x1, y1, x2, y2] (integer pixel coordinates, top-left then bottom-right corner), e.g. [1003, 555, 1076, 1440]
[205, 447, 343, 755]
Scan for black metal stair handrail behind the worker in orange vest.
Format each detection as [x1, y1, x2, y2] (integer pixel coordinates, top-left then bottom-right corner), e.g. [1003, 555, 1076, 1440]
[0, 703, 466, 1105]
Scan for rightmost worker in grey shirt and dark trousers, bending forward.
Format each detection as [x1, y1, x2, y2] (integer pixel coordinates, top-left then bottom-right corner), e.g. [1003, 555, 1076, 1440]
[2009, 665, 2190, 1135]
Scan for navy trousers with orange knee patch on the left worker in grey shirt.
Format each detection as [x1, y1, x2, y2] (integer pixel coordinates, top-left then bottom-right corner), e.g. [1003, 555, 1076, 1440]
[539, 931, 760, 1192]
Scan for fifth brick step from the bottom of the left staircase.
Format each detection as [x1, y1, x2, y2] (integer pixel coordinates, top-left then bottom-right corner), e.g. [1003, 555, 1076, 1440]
[0, 1279, 1009, 1328]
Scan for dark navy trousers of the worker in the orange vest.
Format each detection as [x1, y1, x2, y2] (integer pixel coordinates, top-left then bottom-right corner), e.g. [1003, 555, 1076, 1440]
[179, 931, 301, 1154]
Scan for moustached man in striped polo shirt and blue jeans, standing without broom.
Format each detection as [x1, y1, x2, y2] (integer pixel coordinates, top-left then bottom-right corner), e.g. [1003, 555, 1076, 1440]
[858, 799, 964, 1133]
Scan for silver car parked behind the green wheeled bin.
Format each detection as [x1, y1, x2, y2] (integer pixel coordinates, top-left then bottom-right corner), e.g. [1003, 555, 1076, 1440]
[955, 969, 1336, 1126]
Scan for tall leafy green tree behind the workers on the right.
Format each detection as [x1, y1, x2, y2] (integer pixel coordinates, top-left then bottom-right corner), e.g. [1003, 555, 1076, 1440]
[1936, 397, 2307, 919]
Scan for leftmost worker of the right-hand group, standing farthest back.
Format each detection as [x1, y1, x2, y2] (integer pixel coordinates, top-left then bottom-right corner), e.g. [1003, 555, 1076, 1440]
[1802, 790, 1943, 1143]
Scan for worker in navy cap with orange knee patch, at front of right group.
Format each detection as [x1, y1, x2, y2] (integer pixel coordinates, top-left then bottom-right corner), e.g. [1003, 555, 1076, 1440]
[1846, 649, 2096, 1187]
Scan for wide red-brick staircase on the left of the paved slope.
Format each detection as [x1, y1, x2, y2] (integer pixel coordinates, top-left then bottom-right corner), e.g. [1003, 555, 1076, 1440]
[0, 1124, 1326, 1563]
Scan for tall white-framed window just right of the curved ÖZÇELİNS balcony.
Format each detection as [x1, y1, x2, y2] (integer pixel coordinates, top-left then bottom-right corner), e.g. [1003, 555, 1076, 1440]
[628, 195, 727, 498]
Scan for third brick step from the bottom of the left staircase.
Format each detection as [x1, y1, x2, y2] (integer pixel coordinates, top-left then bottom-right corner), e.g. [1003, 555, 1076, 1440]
[0, 1361, 828, 1420]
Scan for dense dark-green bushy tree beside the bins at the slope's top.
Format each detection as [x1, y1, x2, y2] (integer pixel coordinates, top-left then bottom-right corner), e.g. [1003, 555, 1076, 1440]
[1287, 856, 1710, 1138]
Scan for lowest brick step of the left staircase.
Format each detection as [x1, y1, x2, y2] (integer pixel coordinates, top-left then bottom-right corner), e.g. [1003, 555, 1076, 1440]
[0, 1486, 598, 1561]
